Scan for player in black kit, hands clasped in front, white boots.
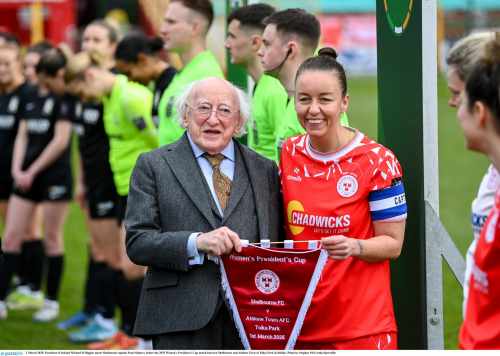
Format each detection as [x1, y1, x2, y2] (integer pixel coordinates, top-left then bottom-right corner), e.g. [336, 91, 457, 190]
[0, 48, 72, 322]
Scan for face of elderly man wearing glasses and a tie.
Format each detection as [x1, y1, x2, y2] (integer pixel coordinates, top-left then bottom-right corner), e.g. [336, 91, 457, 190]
[183, 78, 242, 154]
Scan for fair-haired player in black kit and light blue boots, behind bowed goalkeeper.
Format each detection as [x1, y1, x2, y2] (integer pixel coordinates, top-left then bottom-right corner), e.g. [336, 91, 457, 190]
[58, 20, 122, 343]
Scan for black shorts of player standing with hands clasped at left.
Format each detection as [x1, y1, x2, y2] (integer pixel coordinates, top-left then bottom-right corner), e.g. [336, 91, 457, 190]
[12, 169, 73, 203]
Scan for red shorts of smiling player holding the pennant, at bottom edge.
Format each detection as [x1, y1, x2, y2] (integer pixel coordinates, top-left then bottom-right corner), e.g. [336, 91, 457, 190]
[295, 333, 398, 350]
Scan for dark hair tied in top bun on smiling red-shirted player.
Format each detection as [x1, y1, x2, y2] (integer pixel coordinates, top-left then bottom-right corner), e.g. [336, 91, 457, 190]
[295, 47, 347, 96]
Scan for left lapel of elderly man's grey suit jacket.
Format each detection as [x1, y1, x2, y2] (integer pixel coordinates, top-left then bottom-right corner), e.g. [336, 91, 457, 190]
[163, 134, 217, 229]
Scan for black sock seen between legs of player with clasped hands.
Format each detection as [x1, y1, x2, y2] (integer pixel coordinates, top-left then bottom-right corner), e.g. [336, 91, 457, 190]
[21, 240, 45, 291]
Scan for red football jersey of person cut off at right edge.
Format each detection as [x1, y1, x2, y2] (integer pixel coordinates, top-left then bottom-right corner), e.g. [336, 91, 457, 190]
[460, 189, 500, 349]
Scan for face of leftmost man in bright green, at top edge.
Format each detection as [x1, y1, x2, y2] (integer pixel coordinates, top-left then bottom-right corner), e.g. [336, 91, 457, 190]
[160, 2, 195, 53]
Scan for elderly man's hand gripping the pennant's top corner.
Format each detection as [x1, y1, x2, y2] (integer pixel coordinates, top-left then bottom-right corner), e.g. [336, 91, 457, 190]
[196, 226, 241, 256]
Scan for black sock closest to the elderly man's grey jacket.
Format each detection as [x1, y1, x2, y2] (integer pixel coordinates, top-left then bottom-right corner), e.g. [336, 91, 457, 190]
[117, 273, 144, 336]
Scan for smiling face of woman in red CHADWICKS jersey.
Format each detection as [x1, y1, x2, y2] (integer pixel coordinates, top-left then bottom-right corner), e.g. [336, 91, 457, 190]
[295, 70, 349, 144]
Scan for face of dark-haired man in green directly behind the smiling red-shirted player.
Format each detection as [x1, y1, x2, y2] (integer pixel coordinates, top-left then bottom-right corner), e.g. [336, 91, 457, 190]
[258, 24, 289, 76]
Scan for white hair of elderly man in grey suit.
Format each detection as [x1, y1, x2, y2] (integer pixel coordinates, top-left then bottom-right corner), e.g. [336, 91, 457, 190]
[175, 77, 250, 136]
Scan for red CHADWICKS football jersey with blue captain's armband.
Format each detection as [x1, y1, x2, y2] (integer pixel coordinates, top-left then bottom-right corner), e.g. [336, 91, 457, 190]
[280, 132, 406, 343]
